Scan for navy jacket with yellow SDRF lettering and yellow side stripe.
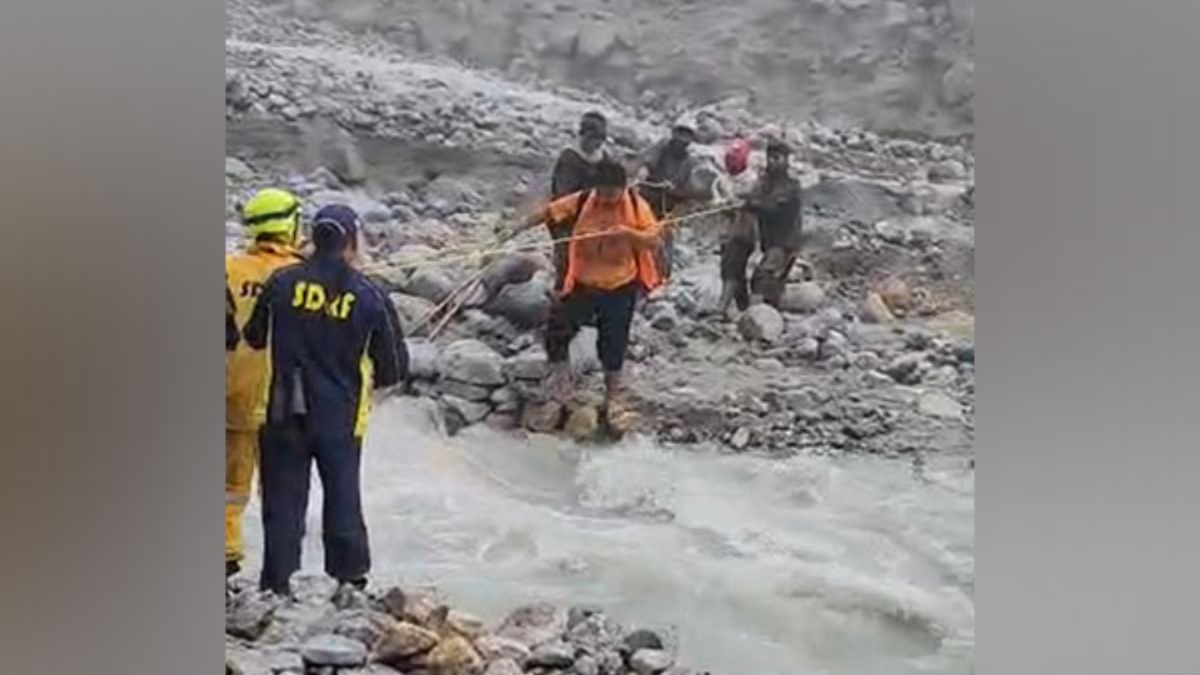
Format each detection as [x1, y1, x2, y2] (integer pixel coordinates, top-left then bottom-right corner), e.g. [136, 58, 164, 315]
[242, 253, 408, 438]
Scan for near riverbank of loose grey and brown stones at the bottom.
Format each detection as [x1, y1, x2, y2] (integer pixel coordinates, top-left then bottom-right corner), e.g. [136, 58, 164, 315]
[226, 577, 694, 675]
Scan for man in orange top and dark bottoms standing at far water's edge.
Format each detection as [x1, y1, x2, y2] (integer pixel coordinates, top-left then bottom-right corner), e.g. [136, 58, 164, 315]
[523, 160, 662, 429]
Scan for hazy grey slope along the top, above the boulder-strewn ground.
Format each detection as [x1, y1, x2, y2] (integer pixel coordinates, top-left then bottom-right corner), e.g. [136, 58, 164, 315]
[246, 0, 974, 136]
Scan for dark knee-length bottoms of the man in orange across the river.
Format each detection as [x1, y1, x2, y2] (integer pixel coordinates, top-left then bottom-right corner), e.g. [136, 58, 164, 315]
[546, 282, 640, 372]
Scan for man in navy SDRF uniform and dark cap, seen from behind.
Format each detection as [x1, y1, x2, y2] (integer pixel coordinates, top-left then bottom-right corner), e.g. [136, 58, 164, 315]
[244, 204, 408, 595]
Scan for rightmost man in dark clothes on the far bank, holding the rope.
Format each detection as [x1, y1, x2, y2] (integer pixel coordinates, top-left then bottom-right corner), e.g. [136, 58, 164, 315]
[744, 141, 800, 307]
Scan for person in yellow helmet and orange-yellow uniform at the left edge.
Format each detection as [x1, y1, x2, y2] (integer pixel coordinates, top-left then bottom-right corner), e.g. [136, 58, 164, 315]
[226, 187, 300, 577]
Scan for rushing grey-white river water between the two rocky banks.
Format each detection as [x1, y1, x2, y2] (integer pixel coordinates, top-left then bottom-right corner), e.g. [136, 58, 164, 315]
[238, 400, 974, 675]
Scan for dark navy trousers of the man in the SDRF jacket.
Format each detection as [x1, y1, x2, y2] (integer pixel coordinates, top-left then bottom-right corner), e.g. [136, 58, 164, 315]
[259, 417, 371, 595]
